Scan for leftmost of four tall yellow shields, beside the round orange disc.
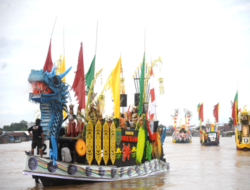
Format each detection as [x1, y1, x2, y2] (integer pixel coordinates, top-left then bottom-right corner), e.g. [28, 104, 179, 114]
[86, 121, 94, 165]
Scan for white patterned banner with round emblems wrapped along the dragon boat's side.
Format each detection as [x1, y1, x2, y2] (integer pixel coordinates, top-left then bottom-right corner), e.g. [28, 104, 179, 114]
[23, 156, 169, 181]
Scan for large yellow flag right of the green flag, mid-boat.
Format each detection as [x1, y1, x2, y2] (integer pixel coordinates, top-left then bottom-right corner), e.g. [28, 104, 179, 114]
[108, 57, 121, 118]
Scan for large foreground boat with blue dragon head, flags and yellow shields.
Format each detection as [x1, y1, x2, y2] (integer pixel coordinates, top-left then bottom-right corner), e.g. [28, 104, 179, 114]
[23, 37, 169, 186]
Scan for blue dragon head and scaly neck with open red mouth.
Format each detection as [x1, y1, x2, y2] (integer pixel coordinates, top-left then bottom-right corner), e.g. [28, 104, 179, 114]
[28, 67, 71, 139]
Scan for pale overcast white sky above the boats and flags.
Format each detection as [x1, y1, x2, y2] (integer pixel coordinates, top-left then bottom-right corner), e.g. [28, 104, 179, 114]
[0, 0, 250, 127]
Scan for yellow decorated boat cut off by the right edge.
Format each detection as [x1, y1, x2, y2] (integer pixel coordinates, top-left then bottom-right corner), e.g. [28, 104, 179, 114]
[235, 106, 250, 151]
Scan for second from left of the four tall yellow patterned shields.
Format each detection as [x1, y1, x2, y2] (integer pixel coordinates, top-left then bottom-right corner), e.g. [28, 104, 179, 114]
[95, 120, 102, 165]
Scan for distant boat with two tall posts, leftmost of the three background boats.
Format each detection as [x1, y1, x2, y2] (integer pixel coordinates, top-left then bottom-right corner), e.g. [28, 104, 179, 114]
[172, 110, 192, 143]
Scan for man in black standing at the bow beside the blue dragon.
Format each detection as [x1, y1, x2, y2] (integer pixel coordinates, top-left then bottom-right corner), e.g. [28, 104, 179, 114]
[28, 119, 44, 157]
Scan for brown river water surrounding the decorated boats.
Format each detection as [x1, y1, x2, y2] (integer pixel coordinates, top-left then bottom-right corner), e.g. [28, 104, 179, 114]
[0, 137, 250, 190]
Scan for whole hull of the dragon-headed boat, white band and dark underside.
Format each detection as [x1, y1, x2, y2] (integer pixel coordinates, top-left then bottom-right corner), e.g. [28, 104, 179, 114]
[23, 155, 169, 187]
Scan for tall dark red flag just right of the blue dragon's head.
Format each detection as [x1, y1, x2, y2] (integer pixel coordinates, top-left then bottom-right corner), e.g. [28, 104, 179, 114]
[72, 43, 85, 110]
